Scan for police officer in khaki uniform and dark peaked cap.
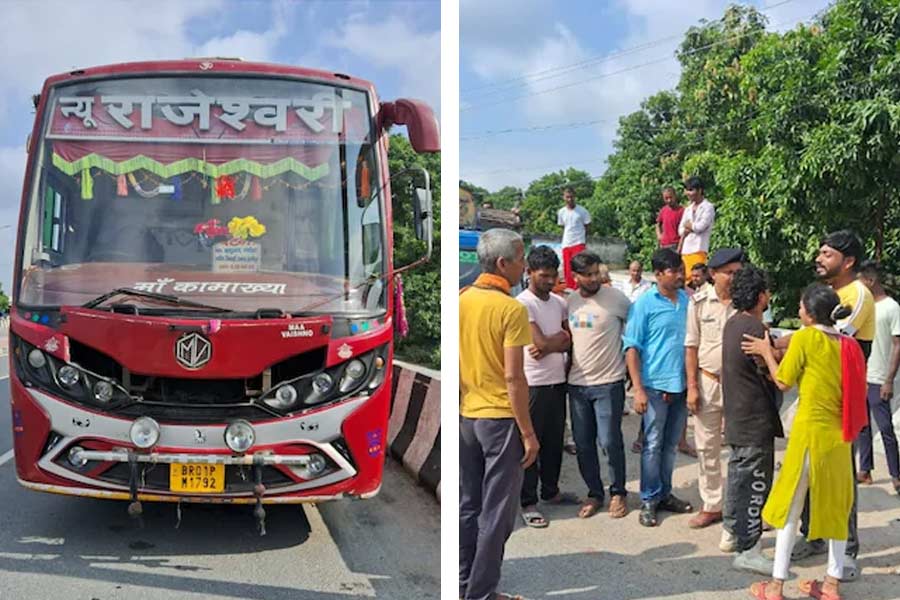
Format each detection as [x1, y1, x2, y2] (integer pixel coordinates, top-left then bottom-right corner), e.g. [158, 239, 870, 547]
[684, 248, 744, 549]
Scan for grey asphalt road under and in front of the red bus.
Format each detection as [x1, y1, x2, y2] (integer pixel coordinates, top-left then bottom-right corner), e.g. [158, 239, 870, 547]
[0, 360, 440, 600]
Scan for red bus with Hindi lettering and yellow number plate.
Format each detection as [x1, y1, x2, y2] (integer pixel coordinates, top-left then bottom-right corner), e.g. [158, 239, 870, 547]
[10, 58, 440, 531]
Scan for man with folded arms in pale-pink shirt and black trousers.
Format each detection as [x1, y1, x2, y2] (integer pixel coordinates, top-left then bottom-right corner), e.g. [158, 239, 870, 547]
[516, 246, 578, 528]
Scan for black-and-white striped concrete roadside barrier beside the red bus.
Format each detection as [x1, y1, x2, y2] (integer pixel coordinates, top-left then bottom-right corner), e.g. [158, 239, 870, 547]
[388, 360, 441, 500]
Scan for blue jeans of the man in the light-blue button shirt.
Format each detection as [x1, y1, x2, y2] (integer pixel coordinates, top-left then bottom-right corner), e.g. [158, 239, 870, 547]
[641, 388, 687, 504]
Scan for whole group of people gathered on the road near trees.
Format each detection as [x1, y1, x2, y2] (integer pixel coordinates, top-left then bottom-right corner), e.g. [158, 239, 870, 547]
[459, 179, 900, 600]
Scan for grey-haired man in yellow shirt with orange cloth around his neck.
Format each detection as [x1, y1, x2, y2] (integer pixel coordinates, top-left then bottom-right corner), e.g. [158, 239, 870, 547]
[459, 229, 539, 600]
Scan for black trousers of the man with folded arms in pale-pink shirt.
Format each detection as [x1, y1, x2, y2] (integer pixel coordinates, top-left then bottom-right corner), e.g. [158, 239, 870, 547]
[521, 383, 566, 507]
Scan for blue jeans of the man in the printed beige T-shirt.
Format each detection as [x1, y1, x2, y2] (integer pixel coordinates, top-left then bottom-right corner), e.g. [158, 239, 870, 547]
[569, 381, 626, 500]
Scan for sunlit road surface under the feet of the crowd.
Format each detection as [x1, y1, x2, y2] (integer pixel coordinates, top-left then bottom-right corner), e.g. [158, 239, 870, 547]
[500, 400, 900, 600]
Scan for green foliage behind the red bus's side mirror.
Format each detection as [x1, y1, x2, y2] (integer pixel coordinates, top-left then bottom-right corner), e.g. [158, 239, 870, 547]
[388, 135, 441, 369]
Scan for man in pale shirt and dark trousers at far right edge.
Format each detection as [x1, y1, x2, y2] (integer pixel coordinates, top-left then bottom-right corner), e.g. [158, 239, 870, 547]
[857, 261, 900, 494]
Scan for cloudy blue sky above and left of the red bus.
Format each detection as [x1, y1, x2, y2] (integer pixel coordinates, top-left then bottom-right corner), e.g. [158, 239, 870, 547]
[0, 0, 441, 292]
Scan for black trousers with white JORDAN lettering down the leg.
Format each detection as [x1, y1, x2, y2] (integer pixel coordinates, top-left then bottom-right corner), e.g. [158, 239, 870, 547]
[722, 444, 775, 552]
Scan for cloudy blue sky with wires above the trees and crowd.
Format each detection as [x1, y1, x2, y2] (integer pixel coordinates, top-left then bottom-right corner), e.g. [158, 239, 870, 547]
[459, 0, 829, 191]
